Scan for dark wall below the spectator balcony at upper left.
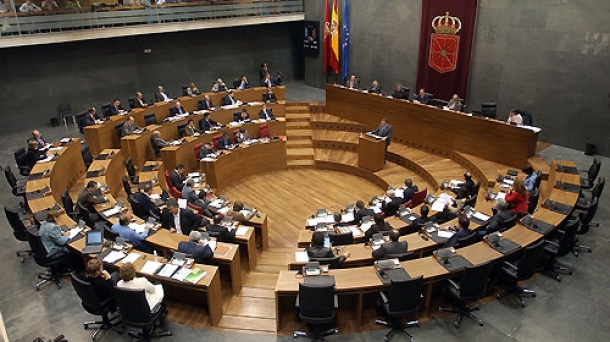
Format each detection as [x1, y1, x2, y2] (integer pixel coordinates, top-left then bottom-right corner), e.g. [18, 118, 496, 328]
[0, 23, 303, 133]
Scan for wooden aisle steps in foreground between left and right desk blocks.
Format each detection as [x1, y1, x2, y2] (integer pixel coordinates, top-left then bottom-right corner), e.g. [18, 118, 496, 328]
[218, 248, 292, 334]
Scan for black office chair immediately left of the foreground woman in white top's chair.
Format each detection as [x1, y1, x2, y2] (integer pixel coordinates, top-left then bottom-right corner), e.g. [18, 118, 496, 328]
[71, 273, 123, 341]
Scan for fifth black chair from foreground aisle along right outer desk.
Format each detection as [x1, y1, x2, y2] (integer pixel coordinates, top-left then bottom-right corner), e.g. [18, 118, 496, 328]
[542, 217, 580, 281]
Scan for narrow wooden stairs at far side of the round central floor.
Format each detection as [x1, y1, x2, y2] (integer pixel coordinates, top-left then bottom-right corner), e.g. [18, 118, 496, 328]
[286, 103, 315, 169]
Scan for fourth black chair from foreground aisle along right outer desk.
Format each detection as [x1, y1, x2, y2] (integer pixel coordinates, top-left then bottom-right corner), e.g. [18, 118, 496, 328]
[498, 240, 544, 308]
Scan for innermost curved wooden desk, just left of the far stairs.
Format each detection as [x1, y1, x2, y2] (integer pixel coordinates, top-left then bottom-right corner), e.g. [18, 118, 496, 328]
[199, 140, 287, 192]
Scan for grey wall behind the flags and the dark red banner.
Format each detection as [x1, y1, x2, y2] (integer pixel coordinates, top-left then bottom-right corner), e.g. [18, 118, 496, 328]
[305, 0, 610, 155]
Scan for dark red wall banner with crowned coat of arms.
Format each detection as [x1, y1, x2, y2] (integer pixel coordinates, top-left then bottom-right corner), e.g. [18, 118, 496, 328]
[416, 0, 478, 100]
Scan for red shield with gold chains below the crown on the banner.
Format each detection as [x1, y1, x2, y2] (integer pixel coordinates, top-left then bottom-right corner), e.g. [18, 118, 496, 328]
[428, 33, 460, 74]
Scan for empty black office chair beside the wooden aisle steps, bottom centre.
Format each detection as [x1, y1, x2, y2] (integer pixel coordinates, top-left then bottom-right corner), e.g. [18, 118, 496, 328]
[292, 283, 339, 341]
